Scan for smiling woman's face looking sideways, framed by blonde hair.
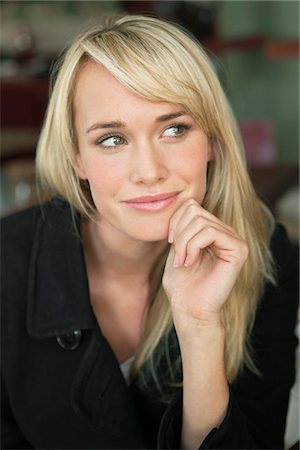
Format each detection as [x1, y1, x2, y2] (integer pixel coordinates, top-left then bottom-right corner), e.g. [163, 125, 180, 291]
[74, 62, 211, 242]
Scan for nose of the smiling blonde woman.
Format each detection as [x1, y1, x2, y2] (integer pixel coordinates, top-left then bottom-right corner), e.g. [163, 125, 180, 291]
[131, 142, 168, 185]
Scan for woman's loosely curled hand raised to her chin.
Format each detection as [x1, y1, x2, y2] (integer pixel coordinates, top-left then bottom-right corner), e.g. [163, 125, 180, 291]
[163, 199, 248, 326]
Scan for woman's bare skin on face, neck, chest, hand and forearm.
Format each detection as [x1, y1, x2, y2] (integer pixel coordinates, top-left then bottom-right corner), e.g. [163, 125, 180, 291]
[74, 62, 247, 448]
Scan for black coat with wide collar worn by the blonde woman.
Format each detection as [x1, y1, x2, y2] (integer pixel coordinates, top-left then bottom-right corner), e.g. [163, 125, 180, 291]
[1, 201, 298, 449]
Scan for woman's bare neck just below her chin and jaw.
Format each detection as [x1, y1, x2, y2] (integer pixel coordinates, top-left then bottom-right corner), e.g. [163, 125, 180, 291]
[82, 220, 167, 283]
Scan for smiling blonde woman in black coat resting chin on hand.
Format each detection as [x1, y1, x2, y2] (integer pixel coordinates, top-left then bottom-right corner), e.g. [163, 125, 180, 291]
[2, 16, 297, 449]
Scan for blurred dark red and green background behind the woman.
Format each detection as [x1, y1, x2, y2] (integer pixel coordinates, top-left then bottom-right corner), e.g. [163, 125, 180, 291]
[0, 0, 299, 246]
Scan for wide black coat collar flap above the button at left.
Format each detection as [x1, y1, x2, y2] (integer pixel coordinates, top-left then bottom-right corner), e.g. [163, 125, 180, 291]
[27, 199, 97, 338]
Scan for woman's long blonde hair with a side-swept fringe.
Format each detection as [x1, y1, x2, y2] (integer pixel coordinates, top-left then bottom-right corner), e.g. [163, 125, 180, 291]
[37, 15, 273, 386]
